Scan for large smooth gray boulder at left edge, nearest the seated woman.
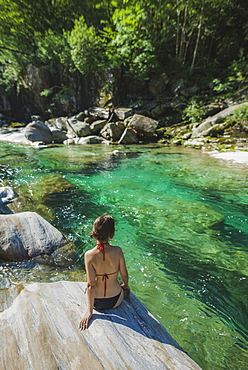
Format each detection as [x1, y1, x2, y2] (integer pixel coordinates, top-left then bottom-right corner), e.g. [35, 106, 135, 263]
[0, 212, 68, 261]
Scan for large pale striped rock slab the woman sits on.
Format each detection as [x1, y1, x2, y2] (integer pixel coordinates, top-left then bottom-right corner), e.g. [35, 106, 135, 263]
[0, 281, 200, 370]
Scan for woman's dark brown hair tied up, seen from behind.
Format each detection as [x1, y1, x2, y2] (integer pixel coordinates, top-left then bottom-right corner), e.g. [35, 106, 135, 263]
[90, 214, 115, 241]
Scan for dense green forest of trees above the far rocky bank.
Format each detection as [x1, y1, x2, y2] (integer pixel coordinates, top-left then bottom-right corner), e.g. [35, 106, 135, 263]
[0, 0, 248, 120]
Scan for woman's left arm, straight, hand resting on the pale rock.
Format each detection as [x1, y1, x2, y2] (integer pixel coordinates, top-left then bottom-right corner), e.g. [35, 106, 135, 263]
[79, 252, 96, 330]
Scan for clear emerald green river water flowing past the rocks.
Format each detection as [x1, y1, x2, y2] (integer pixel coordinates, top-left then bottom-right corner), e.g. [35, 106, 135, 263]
[0, 144, 248, 370]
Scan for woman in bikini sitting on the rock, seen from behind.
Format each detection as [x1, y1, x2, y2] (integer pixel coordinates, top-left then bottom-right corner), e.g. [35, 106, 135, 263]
[79, 215, 130, 330]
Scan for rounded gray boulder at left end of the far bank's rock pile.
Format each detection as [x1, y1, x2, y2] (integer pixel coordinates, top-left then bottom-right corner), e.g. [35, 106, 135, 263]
[25, 121, 53, 144]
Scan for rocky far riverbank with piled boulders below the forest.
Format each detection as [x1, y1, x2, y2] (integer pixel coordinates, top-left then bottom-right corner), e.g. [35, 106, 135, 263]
[0, 102, 248, 150]
